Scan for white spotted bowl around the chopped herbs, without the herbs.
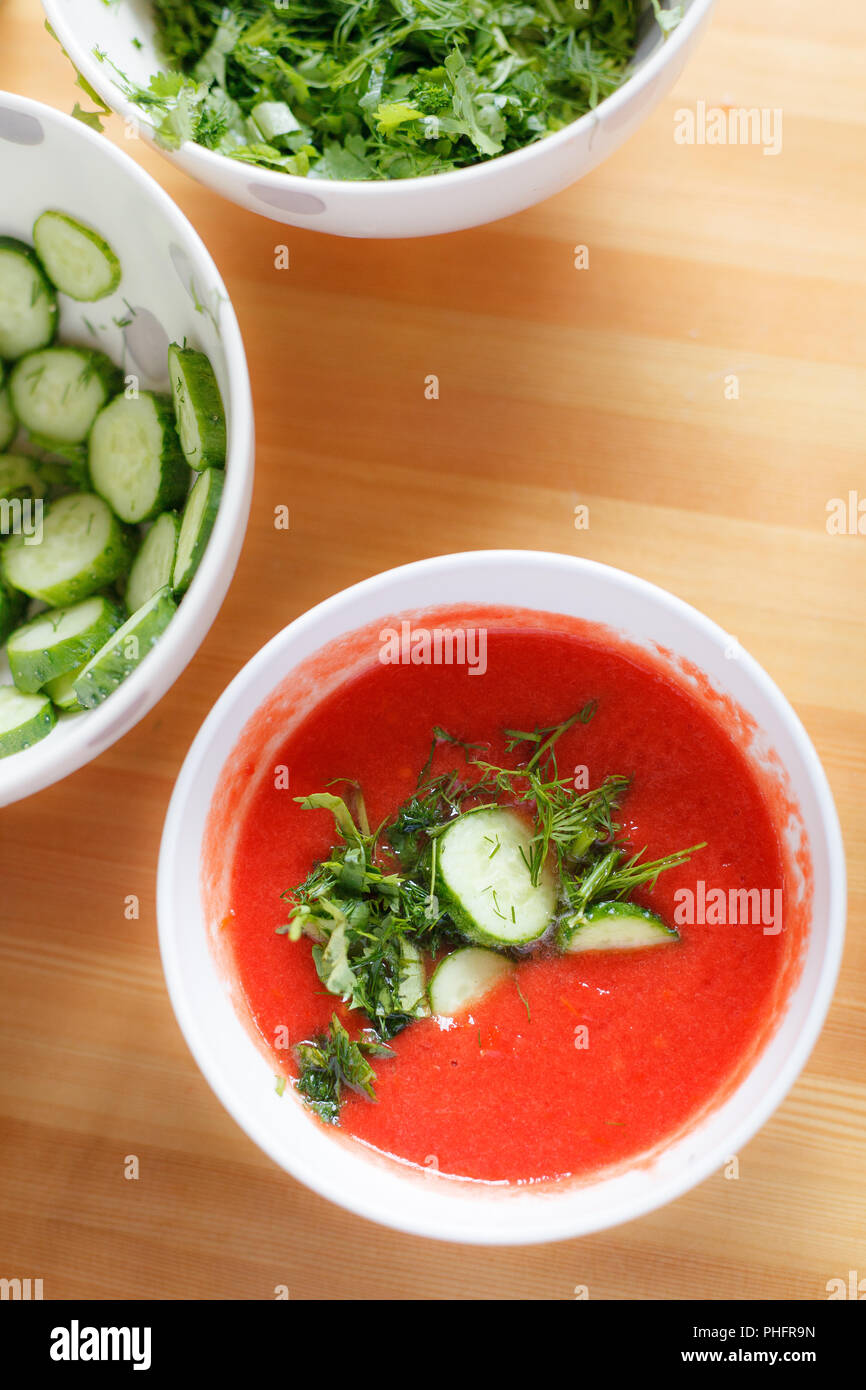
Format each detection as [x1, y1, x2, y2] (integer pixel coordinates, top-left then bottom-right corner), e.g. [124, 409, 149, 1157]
[43, 0, 714, 236]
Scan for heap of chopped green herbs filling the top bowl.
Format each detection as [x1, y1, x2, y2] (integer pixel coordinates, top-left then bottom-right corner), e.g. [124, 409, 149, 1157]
[96, 0, 683, 179]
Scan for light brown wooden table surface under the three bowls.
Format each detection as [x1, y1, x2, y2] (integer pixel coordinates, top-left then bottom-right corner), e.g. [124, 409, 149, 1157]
[0, 0, 866, 1300]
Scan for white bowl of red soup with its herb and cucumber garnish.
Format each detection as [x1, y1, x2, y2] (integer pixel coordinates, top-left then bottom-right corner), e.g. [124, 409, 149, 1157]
[158, 552, 845, 1243]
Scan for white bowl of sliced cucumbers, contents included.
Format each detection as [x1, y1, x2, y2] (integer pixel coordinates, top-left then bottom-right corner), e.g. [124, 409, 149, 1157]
[0, 92, 253, 805]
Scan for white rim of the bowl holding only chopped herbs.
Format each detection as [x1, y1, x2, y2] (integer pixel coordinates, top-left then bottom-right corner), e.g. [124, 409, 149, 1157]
[42, 0, 716, 201]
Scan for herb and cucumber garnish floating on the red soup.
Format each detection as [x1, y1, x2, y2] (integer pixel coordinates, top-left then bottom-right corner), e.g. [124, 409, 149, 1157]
[278, 702, 703, 1123]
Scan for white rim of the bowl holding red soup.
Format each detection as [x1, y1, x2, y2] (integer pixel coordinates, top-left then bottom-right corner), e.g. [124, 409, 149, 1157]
[157, 549, 847, 1245]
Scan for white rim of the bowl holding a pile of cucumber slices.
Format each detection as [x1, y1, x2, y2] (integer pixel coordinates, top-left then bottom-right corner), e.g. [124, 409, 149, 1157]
[0, 92, 254, 806]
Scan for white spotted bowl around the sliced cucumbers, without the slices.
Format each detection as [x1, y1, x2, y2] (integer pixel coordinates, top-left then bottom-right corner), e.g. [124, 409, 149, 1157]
[0, 92, 253, 806]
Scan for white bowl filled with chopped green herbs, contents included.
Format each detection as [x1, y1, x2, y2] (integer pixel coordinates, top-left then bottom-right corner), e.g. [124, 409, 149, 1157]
[43, 0, 713, 236]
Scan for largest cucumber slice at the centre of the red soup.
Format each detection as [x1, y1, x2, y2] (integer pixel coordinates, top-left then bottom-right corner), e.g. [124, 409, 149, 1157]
[435, 806, 557, 948]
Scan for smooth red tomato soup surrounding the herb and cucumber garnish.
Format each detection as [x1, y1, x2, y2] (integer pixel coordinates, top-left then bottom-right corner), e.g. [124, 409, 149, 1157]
[222, 620, 792, 1182]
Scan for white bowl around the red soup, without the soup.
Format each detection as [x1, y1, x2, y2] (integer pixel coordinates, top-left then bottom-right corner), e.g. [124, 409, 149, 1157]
[158, 552, 845, 1244]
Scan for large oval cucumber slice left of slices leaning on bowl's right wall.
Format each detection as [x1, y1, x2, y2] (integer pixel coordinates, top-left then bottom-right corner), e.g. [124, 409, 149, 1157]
[88, 391, 189, 523]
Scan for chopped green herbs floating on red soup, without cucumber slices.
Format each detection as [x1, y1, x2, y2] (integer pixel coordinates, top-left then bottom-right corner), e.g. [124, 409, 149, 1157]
[277, 702, 703, 1125]
